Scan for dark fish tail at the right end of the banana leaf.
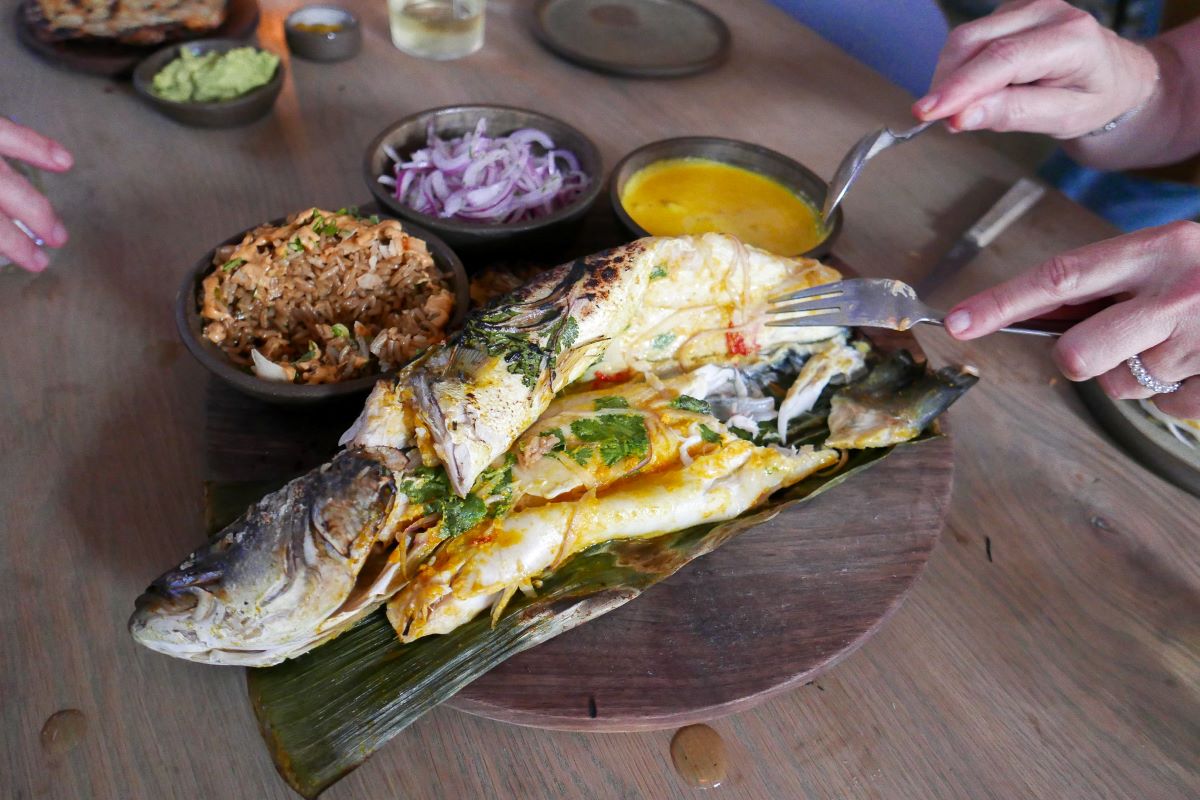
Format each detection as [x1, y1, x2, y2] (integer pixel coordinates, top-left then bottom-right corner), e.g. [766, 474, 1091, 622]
[826, 350, 979, 450]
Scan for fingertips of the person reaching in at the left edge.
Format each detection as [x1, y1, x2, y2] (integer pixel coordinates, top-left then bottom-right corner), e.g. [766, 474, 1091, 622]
[0, 116, 74, 272]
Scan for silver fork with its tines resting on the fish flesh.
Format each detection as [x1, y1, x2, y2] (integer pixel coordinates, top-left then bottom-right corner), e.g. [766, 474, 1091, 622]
[767, 278, 1062, 336]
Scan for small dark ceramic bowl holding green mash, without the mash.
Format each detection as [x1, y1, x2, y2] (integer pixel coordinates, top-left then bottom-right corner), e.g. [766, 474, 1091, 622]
[133, 38, 283, 128]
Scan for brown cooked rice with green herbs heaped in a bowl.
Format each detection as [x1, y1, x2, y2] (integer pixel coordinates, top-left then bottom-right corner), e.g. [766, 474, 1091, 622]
[199, 209, 454, 384]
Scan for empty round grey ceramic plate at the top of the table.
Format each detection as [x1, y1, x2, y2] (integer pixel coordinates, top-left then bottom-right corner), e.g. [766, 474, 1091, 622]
[534, 0, 732, 78]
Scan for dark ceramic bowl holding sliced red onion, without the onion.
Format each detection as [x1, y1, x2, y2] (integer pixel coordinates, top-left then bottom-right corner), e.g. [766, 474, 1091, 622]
[362, 106, 604, 251]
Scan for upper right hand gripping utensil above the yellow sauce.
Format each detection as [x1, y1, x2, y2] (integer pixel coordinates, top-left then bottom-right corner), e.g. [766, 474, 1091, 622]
[912, 0, 1158, 139]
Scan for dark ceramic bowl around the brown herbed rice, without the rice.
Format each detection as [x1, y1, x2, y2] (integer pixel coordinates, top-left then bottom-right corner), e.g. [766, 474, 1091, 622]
[175, 211, 470, 405]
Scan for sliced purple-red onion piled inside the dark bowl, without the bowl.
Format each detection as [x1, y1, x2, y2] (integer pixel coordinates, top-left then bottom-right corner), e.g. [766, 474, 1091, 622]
[379, 120, 590, 223]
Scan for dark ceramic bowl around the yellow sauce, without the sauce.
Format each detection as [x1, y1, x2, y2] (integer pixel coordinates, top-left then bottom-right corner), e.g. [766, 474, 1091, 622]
[608, 136, 841, 258]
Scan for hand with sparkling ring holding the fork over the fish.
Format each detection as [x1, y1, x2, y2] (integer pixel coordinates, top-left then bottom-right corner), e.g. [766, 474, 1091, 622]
[946, 222, 1200, 419]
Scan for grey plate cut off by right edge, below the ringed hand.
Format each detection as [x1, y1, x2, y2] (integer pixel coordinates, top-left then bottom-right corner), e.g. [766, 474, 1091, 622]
[1079, 380, 1200, 497]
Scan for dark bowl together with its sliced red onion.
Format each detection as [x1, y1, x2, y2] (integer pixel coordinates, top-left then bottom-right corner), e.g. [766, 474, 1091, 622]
[362, 106, 604, 249]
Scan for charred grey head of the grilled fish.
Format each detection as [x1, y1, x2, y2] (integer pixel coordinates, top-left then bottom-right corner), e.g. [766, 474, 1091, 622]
[128, 450, 403, 666]
